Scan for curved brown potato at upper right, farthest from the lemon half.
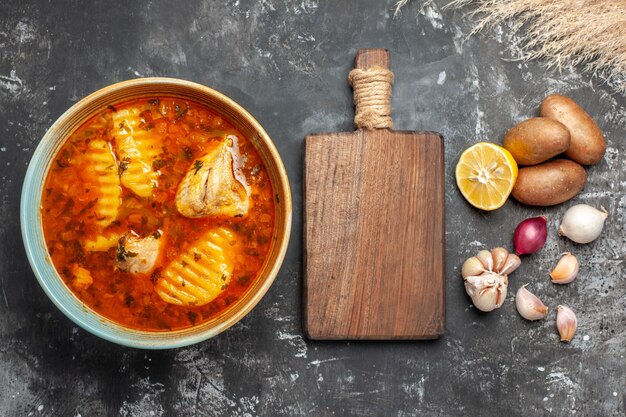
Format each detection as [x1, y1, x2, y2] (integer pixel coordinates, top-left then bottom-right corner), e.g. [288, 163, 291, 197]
[539, 94, 606, 165]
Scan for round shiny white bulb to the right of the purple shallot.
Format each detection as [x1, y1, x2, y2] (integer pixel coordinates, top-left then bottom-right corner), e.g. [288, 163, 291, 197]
[559, 204, 608, 243]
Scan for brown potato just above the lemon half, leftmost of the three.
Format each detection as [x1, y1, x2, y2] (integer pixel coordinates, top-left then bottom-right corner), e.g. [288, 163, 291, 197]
[502, 117, 570, 165]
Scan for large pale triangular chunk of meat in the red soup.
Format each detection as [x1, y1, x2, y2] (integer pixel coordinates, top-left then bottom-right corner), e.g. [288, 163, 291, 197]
[176, 136, 250, 218]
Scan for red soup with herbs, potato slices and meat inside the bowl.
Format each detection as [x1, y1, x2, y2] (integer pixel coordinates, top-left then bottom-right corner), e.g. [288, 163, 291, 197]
[41, 97, 275, 331]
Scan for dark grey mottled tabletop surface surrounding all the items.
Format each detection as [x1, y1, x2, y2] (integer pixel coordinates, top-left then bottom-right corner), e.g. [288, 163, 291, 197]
[0, 0, 626, 417]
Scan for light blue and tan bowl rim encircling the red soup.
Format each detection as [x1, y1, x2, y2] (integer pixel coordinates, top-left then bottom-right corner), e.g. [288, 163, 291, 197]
[20, 77, 292, 349]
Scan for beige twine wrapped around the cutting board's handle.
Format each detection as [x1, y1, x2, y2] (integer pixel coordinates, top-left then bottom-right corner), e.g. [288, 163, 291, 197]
[348, 67, 393, 130]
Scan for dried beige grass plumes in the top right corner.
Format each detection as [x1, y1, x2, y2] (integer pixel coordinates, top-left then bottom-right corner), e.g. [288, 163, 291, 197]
[396, 0, 626, 94]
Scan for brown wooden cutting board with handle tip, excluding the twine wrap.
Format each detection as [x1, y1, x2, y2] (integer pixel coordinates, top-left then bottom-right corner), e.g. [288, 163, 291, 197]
[304, 49, 445, 339]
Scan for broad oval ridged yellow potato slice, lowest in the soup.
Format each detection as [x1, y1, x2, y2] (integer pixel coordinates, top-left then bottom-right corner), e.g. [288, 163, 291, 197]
[155, 227, 237, 307]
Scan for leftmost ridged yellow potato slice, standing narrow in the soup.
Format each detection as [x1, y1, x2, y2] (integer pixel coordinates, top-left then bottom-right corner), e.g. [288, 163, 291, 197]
[85, 140, 122, 228]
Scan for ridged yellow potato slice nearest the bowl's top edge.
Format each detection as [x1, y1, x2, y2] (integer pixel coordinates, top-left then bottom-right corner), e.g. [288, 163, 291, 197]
[112, 107, 160, 197]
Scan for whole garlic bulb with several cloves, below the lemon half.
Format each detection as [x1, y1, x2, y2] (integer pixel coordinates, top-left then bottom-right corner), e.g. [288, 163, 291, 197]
[461, 248, 522, 312]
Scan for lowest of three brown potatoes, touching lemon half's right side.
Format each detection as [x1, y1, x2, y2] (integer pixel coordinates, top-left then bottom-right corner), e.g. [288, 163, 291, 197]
[511, 159, 587, 206]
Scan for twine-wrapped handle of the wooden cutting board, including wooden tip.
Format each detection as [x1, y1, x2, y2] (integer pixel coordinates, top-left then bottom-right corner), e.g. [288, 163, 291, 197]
[348, 48, 393, 130]
